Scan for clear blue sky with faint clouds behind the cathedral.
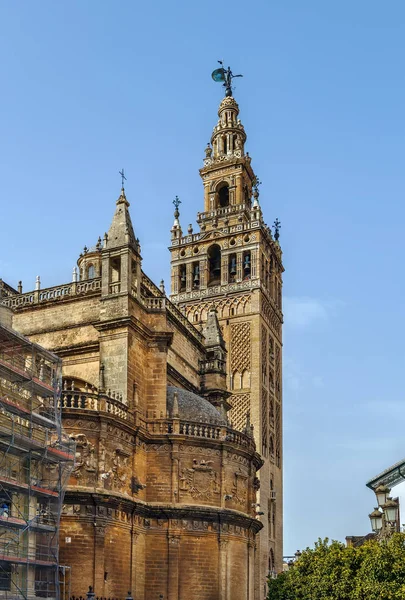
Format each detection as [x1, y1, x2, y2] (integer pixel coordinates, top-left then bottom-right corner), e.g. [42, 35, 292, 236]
[0, 0, 405, 554]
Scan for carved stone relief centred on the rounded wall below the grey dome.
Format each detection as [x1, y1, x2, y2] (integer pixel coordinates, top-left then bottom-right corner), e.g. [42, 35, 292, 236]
[180, 459, 221, 500]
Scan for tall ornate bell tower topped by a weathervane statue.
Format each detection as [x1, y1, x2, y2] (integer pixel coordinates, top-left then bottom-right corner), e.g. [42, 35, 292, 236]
[170, 69, 283, 600]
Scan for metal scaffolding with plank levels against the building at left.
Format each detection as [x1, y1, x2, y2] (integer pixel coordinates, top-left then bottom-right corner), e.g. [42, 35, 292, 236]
[0, 325, 74, 600]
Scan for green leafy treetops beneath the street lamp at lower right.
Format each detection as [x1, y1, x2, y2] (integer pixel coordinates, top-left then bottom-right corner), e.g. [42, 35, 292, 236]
[268, 533, 405, 600]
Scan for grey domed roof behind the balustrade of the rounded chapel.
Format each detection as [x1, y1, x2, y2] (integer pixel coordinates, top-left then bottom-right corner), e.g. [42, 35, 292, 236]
[167, 385, 227, 425]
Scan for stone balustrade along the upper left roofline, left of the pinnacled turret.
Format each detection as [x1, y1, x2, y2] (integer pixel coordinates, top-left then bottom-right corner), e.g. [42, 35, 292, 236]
[2, 277, 101, 308]
